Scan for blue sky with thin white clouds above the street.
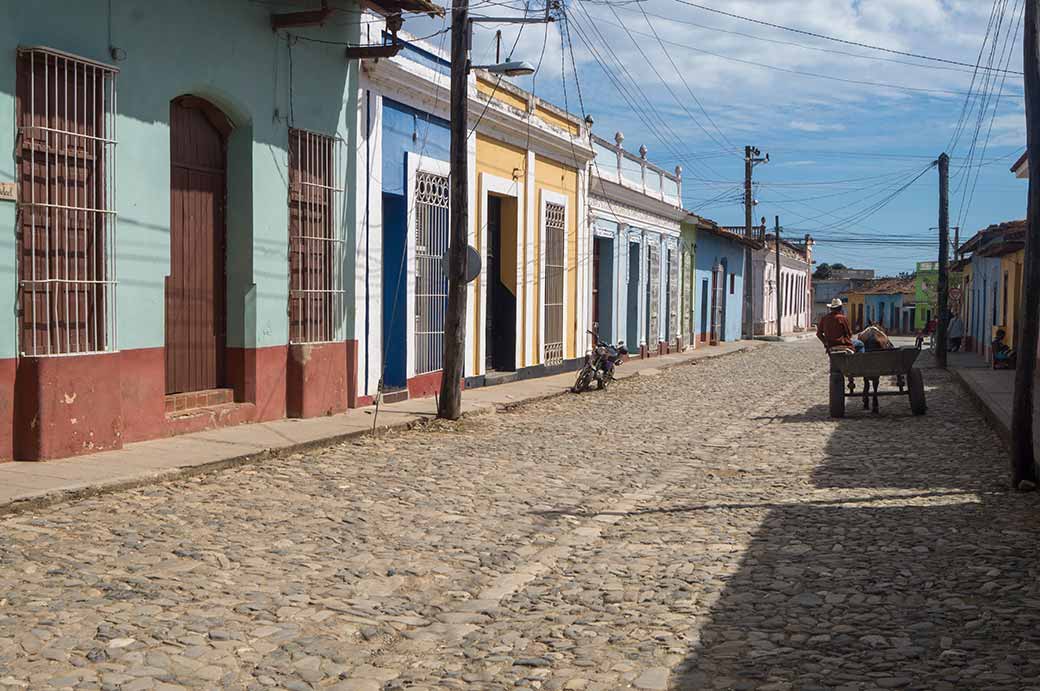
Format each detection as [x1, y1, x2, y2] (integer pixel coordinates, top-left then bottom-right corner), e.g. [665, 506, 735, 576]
[406, 0, 1026, 275]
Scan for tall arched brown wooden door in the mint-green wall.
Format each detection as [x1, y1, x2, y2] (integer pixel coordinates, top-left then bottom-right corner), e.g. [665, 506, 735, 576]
[166, 96, 230, 393]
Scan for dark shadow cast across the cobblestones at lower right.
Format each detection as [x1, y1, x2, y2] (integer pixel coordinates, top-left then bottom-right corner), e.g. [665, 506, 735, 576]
[670, 369, 1040, 689]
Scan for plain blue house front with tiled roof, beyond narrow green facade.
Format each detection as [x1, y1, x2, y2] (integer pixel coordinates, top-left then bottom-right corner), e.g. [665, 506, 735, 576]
[694, 224, 747, 342]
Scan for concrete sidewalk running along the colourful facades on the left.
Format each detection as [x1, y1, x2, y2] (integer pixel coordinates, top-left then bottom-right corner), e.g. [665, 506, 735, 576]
[0, 341, 764, 514]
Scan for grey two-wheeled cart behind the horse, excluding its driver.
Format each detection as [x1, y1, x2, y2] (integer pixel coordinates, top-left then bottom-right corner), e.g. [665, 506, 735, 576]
[830, 348, 928, 417]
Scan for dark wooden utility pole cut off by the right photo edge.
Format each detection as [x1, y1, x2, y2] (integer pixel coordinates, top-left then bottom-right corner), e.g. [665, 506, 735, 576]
[1011, 0, 1040, 488]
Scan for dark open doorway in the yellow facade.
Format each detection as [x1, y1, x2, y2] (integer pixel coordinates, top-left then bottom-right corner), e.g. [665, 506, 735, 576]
[484, 195, 517, 372]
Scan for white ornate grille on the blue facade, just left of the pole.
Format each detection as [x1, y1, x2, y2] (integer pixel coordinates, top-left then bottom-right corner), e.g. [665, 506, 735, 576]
[415, 171, 449, 375]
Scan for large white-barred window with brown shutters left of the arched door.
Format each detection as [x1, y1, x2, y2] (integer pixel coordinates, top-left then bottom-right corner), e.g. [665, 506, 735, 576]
[16, 48, 118, 357]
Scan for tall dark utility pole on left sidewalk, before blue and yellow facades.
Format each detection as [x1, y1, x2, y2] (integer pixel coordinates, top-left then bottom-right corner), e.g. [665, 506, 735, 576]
[437, 0, 469, 419]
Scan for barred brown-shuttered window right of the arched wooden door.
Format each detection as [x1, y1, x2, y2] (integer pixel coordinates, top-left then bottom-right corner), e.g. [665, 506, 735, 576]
[289, 129, 344, 343]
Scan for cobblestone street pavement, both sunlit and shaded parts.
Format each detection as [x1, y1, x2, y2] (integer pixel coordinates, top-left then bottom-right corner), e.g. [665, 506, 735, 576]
[0, 343, 1040, 691]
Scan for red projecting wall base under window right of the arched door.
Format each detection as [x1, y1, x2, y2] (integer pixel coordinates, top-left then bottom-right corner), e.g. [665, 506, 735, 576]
[285, 342, 347, 417]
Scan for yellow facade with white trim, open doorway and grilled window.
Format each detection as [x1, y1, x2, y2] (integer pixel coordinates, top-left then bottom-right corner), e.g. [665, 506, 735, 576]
[466, 73, 592, 386]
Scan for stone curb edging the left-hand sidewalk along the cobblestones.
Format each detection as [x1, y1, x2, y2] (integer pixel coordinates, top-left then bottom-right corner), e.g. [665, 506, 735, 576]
[0, 343, 764, 517]
